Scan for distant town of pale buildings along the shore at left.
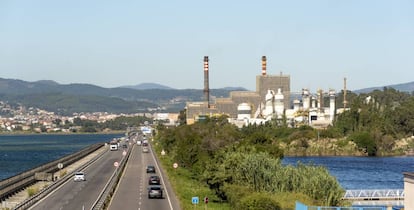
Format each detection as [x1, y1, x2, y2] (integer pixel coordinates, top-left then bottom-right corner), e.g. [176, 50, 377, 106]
[0, 101, 178, 133]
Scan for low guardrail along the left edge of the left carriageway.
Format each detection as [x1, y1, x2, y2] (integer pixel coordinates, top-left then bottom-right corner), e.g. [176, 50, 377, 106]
[13, 144, 107, 210]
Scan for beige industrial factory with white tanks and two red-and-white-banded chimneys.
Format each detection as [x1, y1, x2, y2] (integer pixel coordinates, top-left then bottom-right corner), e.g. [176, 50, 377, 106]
[186, 56, 342, 128]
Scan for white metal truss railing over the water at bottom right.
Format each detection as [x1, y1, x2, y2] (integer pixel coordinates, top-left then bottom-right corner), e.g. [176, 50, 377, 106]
[343, 189, 404, 200]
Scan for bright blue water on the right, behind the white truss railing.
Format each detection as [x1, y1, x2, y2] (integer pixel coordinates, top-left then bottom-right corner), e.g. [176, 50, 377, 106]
[282, 157, 414, 190]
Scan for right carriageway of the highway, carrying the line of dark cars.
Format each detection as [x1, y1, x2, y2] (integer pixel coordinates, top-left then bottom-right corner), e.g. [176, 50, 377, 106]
[108, 142, 180, 210]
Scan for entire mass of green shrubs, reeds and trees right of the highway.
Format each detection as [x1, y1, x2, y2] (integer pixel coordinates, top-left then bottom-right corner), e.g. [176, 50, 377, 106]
[152, 88, 414, 209]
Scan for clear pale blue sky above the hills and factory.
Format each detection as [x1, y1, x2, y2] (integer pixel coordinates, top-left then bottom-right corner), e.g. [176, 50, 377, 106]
[0, 0, 414, 92]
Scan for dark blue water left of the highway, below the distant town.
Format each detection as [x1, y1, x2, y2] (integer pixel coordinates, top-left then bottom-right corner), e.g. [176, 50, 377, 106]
[0, 134, 123, 180]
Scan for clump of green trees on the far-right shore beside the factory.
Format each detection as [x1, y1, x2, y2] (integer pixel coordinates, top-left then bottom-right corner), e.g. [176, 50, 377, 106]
[327, 88, 414, 156]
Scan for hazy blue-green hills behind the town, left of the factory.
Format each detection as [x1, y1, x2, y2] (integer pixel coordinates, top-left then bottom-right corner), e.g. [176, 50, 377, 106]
[0, 78, 243, 115]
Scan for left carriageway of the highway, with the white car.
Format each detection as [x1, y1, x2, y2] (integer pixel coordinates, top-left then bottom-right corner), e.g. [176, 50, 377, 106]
[30, 146, 122, 210]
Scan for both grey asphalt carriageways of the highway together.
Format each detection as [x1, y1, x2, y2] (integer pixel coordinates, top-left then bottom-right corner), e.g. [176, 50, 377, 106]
[29, 136, 180, 210]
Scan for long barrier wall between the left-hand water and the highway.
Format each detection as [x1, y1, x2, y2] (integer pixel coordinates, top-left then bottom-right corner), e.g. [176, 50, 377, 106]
[0, 143, 104, 200]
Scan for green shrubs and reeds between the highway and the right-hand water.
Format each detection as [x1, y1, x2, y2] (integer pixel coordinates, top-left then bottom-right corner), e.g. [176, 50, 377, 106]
[156, 117, 344, 209]
